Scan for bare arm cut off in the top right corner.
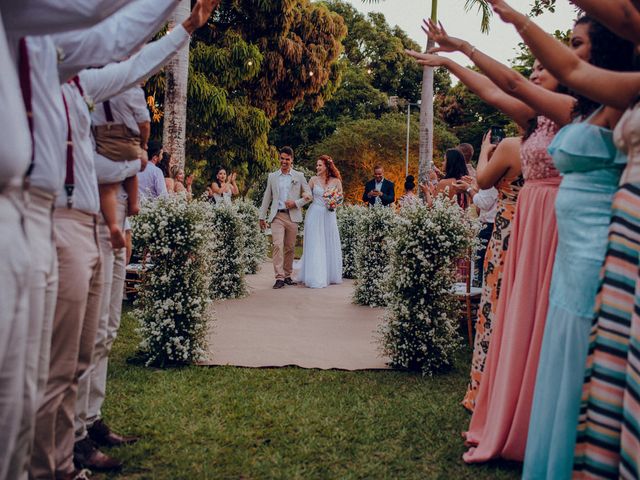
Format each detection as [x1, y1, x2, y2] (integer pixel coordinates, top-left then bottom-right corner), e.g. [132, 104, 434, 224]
[571, 0, 640, 45]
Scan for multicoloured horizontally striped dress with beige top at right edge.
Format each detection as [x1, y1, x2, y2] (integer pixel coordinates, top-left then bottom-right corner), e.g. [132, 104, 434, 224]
[574, 104, 640, 479]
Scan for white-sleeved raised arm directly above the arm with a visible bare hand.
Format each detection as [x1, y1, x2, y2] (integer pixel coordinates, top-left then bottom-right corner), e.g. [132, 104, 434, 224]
[53, 0, 178, 82]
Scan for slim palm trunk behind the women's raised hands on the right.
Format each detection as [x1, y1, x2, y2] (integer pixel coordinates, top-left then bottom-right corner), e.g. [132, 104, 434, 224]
[418, 0, 438, 183]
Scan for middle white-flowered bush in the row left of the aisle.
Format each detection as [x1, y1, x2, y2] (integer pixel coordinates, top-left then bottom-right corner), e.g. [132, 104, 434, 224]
[208, 203, 247, 300]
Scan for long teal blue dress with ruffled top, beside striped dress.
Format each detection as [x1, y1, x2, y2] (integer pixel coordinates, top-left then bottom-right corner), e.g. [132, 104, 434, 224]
[522, 109, 623, 480]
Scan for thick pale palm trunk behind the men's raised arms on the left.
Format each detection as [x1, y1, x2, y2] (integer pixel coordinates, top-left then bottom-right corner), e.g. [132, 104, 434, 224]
[162, 2, 191, 168]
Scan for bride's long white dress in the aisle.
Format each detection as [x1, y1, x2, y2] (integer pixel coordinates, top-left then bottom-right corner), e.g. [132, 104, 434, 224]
[298, 184, 342, 288]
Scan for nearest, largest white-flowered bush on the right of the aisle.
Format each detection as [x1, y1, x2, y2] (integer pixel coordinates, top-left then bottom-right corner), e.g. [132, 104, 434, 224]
[380, 198, 479, 375]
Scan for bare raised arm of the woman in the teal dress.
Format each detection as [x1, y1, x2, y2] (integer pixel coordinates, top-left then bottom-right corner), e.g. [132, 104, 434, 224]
[423, 20, 575, 125]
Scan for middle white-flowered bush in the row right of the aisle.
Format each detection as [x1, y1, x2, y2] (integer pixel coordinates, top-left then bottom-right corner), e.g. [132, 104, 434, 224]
[353, 206, 397, 307]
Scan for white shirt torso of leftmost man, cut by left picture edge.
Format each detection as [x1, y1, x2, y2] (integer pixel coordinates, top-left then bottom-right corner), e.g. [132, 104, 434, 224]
[0, 12, 31, 190]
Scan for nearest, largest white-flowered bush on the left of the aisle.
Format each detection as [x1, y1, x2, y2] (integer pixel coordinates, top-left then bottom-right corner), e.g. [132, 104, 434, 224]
[132, 197, 213, 366]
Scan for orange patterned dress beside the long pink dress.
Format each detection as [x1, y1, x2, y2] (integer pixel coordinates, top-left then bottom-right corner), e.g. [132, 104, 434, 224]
[462, 175, 524, 412]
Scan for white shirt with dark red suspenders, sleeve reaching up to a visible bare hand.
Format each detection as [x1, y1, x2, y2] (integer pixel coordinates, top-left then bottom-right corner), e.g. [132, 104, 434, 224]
[56, 25, 189, 214]
